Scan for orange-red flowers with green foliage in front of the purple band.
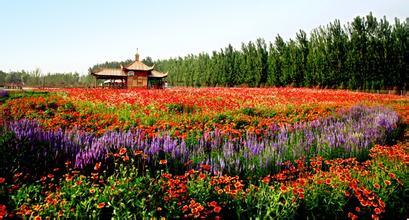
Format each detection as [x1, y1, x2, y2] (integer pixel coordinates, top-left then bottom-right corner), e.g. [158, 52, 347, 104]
[0, 145, 409, 219]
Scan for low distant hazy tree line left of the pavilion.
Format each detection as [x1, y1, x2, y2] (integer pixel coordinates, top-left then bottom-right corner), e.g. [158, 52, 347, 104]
[0, 69, 93, 87]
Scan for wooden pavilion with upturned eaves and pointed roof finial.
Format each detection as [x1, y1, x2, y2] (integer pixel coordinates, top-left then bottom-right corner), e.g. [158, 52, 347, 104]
[91, 53, 168, 89]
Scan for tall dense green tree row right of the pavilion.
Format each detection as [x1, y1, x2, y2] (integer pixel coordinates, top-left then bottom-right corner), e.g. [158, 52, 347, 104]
[150, 13, 409, 90]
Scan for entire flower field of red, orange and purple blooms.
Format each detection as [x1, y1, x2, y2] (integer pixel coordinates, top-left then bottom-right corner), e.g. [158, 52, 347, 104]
[0, 88, 409, 219]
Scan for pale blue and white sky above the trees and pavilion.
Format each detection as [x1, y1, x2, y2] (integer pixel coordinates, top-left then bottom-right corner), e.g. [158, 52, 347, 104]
[0, 0, 409, 74]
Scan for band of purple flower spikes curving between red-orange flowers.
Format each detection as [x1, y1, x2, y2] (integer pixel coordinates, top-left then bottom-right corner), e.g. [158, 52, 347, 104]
[0, 106, 399, 176]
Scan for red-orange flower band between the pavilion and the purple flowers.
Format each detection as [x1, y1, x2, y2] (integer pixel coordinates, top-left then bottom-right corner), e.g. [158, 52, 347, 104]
[2, 88, 409, 138]
